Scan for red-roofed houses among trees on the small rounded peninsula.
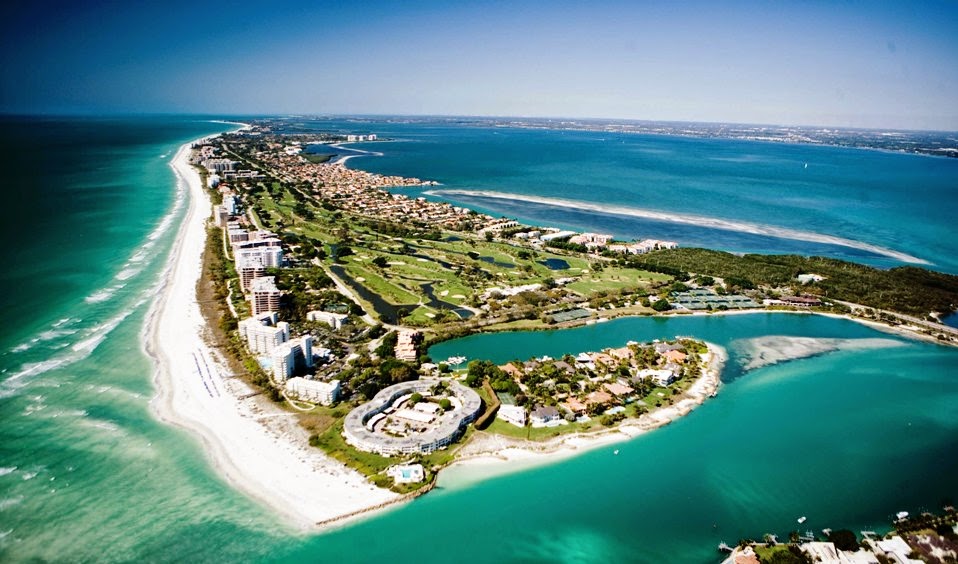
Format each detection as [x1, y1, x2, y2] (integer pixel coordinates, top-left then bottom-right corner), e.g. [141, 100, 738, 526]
[498, 341, 699, 427]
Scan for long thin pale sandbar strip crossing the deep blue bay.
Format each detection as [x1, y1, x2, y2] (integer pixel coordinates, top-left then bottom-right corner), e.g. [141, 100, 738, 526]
[425, 189, 931, 264]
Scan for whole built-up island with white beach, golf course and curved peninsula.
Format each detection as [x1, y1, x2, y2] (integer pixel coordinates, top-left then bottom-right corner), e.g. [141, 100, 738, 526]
[148, 121, 958, 526]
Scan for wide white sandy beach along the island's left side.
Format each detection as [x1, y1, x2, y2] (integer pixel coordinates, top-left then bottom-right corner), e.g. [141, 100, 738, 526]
[144, 139, 399, 529]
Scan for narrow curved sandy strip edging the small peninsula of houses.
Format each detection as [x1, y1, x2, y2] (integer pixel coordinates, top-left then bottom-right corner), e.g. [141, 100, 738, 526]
[438, 342, 729, 486]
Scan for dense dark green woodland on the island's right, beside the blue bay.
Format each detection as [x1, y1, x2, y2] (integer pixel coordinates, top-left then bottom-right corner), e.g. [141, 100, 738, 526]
[632, 249, 958, 317]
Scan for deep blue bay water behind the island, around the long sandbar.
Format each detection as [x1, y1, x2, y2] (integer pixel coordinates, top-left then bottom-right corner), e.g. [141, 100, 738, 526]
[286, 120, 958, 272]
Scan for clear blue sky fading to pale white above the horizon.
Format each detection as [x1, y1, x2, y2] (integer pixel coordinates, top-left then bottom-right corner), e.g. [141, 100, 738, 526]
[0, 0, 958, 131]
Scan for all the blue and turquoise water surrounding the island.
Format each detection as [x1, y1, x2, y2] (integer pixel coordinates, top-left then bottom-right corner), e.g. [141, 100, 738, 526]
[0, 116, 958, 562]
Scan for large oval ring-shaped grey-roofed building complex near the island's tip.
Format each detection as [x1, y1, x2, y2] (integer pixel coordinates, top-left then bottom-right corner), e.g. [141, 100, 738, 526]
[343, 378, 482, 456]
